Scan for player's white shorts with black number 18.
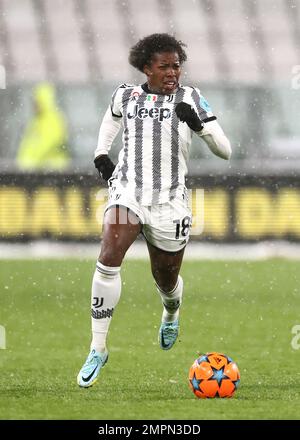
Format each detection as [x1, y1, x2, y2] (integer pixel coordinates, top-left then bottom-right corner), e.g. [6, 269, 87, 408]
[105, 185, 192, 252]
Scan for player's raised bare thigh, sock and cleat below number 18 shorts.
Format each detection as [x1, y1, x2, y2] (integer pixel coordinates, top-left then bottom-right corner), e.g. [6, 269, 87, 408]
[147, 242, 184, 350]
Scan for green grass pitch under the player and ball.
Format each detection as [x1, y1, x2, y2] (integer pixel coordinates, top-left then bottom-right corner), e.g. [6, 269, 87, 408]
[0, 259, 300, 420]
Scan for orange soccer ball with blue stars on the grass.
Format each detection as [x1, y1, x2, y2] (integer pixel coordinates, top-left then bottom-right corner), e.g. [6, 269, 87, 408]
[189, 352, 240, 399]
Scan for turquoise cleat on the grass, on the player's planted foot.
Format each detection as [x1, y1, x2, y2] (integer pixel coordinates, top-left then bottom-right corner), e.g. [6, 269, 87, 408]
[77, 350, 108, 388]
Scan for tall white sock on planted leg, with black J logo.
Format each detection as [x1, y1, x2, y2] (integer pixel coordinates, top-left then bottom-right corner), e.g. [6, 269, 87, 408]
[91, 261, 121, 353]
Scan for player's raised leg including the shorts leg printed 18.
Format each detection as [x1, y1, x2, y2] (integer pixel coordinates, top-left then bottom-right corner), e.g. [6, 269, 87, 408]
[143, 192, 191, 350]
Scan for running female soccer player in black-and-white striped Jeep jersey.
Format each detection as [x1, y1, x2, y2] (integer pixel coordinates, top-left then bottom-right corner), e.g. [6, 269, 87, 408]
[77, 34, 231, 387]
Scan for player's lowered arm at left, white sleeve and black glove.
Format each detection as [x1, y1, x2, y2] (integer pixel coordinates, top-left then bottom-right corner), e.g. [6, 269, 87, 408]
[94, 106, 121, 181]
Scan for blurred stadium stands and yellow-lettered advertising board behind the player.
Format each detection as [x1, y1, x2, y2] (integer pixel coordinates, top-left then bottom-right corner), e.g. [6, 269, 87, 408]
[0, 0, 300, 248]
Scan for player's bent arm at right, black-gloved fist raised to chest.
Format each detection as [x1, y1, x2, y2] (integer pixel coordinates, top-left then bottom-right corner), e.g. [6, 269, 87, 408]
[175, 102, 231, 160]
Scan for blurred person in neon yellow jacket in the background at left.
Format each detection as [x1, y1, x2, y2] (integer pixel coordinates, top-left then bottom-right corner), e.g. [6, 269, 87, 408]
[17, 83, 70, 170]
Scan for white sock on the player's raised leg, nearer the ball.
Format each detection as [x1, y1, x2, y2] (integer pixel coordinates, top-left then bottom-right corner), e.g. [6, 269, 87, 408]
[156, 275, 183, 322]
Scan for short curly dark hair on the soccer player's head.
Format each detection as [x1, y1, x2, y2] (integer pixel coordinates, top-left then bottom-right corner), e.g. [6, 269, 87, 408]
[129, 34, 187, 72]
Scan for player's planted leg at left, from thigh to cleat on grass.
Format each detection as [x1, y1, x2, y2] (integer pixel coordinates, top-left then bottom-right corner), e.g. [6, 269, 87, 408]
[77, 206, 141, 387]
